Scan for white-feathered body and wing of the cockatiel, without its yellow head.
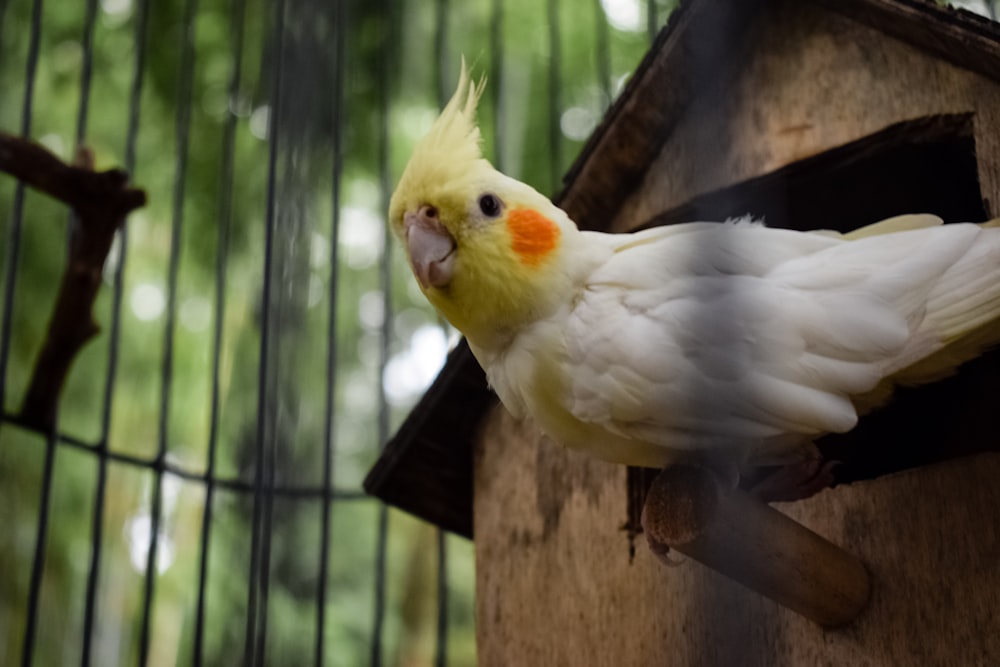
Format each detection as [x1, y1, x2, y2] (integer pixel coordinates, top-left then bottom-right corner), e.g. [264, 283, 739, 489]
[508, 216, 1000, 465]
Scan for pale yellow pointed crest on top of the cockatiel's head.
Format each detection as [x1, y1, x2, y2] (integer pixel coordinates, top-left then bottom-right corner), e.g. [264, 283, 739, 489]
[389, 58, 489, 223]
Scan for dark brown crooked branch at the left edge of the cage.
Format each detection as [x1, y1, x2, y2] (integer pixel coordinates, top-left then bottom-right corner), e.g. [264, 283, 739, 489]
[0, 132, 146, 430]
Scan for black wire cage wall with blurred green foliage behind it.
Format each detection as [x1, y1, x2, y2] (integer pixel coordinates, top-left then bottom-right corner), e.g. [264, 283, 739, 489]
[0, 0, 671, 665]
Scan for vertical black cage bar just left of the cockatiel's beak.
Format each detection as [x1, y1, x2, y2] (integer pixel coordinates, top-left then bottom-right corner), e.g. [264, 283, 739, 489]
[371, 0, 395, 667]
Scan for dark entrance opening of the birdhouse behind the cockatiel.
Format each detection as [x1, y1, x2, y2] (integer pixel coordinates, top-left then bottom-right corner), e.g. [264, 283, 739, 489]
[628, 114, 1000, 526]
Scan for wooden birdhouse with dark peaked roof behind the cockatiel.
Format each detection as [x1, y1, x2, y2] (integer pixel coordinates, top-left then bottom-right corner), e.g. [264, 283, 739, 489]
[366, 0, 1000, 665]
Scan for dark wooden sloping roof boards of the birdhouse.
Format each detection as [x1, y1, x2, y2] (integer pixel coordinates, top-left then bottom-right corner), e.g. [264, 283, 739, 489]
[364, 0, 1000, 537]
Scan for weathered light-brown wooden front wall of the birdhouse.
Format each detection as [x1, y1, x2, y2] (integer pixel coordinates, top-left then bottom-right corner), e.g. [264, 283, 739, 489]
[474, 1, 1000, 667]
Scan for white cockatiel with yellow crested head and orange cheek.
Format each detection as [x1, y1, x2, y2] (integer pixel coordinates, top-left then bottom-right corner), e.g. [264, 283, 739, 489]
[389, 65, 1000, 500]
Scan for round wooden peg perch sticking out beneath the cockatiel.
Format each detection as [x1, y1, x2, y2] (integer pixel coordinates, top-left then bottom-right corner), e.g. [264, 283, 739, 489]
[643, 466, 871, 627]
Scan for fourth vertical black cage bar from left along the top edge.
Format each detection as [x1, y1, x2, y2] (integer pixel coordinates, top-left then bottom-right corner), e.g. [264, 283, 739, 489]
[139, 0, 198, 666]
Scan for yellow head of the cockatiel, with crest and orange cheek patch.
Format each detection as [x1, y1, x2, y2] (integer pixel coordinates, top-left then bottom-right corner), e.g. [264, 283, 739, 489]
[389, 62, 578, 345]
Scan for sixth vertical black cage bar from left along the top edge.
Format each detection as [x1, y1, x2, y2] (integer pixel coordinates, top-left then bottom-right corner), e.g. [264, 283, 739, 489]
[243, 0, 285, 665]
